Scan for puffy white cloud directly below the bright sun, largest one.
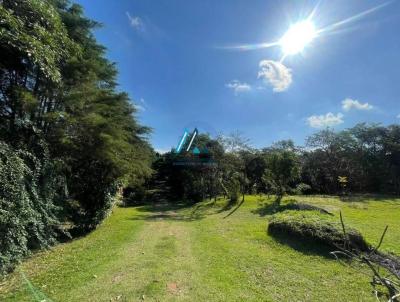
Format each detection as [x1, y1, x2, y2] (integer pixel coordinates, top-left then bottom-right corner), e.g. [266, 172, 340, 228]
[258, 60, 292, 92]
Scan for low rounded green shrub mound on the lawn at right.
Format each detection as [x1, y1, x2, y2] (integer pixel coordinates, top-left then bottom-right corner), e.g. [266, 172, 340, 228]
[268, 211, 370, 251]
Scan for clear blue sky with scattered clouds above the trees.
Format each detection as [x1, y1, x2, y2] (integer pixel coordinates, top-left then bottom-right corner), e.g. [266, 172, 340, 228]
[76, 0, 400, 151]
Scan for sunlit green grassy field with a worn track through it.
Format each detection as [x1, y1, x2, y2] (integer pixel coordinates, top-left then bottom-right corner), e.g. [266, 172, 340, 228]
[0, 196, 400, 301]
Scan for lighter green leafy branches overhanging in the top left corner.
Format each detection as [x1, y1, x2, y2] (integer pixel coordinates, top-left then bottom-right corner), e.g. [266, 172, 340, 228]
[0, 0, 77, 82]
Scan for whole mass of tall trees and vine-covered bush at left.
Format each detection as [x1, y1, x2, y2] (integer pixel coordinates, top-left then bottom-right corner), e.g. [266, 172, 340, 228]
[0, 0, 153, 273]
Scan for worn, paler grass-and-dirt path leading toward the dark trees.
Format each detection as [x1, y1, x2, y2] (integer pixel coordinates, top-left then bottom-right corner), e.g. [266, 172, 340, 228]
[71, 211, 199, 301]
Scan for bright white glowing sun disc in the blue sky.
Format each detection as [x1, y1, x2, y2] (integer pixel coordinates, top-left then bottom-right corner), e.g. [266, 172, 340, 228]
[279, 20, 317, 55]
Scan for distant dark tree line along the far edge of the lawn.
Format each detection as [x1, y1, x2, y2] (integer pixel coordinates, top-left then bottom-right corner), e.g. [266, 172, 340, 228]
[147, 123, 400, 203]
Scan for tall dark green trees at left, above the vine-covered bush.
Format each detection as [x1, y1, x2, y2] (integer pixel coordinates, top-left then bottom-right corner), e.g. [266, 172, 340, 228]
[0, 0, 153, 234]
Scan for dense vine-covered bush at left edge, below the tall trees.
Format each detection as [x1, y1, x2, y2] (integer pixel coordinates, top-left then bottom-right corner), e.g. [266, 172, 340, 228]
[0, 142, 64, 274]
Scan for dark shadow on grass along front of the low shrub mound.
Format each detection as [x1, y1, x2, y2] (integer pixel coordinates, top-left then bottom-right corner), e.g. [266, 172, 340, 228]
[267, 230, 337, 260]
